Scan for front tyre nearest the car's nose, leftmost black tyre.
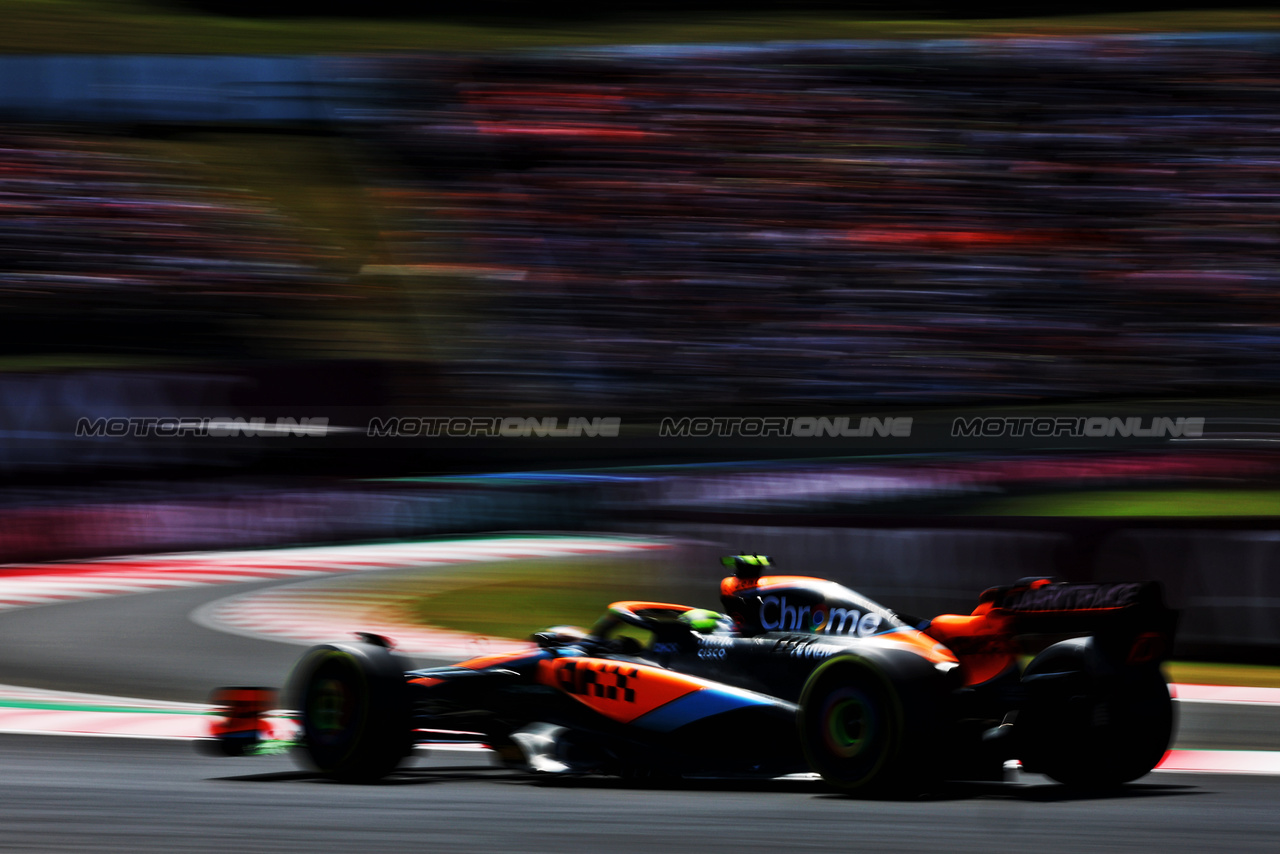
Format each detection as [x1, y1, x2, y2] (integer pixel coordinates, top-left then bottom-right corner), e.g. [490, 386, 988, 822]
[292, 643, 412, 782]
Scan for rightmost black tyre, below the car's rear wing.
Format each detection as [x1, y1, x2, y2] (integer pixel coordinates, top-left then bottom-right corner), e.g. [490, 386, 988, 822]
[1015, 639, 1175, 789]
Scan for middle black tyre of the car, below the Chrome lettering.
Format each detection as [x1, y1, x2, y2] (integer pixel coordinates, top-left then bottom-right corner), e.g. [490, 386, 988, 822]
[797, 657, 931, 795]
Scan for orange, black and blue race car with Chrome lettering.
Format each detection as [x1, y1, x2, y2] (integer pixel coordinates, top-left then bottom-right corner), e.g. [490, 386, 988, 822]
[215, 554, 1178, 794]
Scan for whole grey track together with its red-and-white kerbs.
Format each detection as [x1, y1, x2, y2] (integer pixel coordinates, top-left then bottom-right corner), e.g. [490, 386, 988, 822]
[0, 535, 1280, 853]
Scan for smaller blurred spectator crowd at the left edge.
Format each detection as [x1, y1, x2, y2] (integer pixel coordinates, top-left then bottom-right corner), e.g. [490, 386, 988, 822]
[0, 125, 335, 357]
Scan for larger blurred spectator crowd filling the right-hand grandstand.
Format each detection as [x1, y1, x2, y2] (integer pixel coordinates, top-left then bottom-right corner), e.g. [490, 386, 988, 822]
[366, 36, 1280, 406]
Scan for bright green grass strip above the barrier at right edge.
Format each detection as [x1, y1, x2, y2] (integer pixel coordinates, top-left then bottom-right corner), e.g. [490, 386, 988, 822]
[964, 489, 1280, 517]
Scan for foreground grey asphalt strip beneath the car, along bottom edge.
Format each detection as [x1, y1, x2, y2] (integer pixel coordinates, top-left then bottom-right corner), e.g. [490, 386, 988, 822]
[0, 736, 1280, 854]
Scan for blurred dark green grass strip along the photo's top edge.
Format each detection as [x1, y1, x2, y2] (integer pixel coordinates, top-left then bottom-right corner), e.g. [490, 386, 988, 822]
[0, 0, 1280, 54]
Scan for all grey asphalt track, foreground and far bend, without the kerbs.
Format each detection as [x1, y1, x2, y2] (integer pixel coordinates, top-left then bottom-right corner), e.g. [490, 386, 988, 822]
[0, 573, 1280, 854]
